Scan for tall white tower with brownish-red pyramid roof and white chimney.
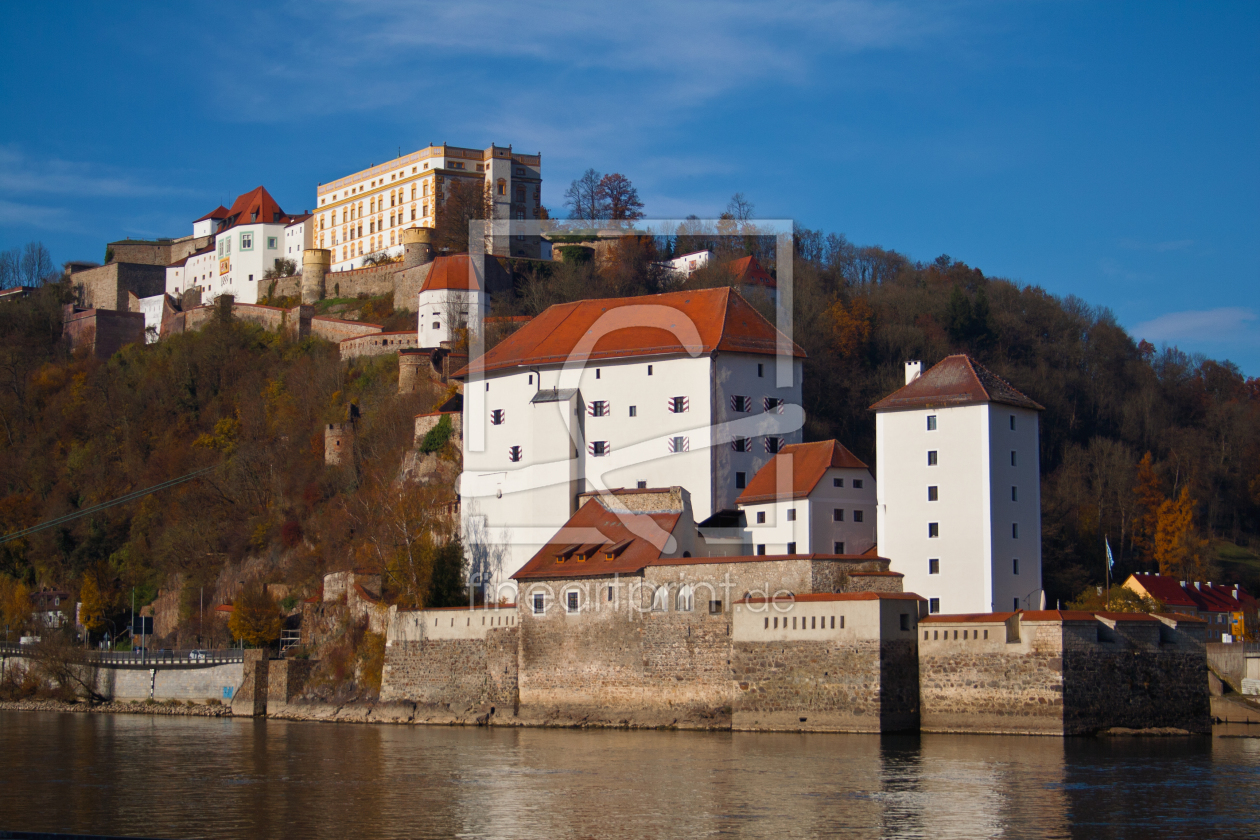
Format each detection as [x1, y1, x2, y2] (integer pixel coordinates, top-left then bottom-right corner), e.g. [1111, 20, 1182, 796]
[871, 355, 1045, 613]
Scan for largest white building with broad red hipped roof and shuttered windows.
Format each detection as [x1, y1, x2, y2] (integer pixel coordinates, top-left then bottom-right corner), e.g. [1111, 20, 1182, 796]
[456, 285, 805, 594]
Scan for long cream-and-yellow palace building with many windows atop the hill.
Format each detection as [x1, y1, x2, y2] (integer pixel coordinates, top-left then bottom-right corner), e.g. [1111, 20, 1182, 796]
[315, 145, 542, 271]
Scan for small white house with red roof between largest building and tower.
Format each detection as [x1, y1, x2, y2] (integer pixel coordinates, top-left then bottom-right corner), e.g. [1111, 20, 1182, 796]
[735, 441, 876, 554]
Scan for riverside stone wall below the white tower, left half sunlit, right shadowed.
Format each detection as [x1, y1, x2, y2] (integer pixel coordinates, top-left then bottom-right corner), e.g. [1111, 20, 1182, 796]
[919, 611, 1210, 735]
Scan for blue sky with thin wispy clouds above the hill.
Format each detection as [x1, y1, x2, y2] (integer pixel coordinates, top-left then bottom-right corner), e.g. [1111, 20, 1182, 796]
[0, 0, 1260, 375]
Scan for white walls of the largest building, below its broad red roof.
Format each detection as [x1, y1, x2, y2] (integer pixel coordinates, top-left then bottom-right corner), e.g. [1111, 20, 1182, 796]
[460, 353, 804, 589]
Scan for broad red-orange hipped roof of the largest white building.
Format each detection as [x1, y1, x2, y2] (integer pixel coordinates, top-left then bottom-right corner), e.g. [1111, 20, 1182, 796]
[455, 288, 805, 378]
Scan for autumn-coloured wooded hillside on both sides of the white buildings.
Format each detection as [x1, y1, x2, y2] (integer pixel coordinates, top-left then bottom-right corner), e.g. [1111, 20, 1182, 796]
[0, 230, 1260, 649]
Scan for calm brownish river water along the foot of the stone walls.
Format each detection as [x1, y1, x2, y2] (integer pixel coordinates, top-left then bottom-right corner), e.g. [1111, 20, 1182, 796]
[0, 712, 1260, 840]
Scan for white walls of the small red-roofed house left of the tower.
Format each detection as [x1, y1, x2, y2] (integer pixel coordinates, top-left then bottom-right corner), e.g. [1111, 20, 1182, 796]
[740, 467, 876, 554]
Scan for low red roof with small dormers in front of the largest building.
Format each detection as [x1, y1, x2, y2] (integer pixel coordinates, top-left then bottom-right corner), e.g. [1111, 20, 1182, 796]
[512, 499, 682, 581]
